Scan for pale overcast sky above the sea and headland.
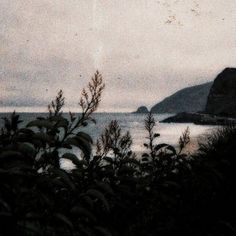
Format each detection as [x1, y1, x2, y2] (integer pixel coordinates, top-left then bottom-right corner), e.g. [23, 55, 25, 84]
[0, 0, 236, 111]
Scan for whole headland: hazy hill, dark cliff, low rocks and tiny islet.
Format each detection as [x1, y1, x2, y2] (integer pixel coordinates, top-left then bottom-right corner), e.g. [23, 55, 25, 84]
[136, 68, 236, 125]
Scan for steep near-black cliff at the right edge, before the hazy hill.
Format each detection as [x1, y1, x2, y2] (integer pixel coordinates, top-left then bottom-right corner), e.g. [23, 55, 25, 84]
[205, 68, 236, 117]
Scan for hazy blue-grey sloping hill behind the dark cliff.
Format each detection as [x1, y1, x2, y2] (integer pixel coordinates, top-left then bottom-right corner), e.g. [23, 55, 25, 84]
[151, 82, 213, 113]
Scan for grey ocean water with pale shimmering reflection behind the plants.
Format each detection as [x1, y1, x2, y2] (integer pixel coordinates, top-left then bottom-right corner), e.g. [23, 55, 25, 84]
[0, 113, 216, 152]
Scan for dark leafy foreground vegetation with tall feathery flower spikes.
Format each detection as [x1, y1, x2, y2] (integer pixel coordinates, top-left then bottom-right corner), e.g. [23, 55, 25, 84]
[0, 72, 236, 236]
